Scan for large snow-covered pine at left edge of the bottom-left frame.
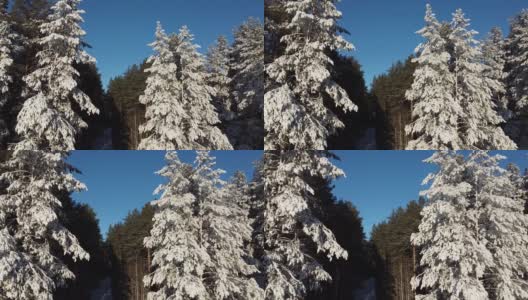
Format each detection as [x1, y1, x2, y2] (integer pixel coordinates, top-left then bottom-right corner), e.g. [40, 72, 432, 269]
[0, 150, 89, 300]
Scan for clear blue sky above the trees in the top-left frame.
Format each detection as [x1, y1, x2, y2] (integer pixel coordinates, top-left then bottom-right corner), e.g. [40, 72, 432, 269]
[81, 0, 264, 86]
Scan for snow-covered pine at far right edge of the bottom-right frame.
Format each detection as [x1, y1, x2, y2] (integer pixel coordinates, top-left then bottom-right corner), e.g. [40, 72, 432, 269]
[466, 151, 528, 300]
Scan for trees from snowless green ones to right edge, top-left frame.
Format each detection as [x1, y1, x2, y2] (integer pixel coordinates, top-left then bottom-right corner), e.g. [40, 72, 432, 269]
[108, 18, 264, 149]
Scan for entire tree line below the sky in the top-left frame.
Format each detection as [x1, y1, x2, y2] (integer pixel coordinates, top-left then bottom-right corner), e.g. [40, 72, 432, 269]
[0, 0, 264, 150]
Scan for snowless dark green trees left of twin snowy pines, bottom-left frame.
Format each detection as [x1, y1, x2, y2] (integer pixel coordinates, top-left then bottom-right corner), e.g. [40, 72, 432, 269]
[107, 204, 154, 300]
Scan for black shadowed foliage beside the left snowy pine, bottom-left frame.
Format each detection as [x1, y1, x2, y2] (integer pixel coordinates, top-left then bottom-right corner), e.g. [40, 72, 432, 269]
[54, 193, 109, 300]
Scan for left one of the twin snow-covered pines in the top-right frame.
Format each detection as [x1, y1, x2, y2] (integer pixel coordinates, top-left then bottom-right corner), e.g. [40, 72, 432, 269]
[405, 4, 464, 150]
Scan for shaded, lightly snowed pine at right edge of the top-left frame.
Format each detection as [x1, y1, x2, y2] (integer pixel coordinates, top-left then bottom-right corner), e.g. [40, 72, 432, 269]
[229, 18, 264, 149]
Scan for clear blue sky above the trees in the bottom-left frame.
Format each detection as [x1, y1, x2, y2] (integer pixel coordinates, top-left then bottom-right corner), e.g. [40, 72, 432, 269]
[69, 150, 262, 236]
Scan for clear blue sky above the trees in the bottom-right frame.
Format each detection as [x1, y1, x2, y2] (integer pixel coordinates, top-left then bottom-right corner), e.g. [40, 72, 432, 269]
[334, 151, 528, 236]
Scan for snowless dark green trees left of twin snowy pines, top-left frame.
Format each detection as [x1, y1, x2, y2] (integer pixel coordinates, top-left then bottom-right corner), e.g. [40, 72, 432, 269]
[108, 61, 148, 150]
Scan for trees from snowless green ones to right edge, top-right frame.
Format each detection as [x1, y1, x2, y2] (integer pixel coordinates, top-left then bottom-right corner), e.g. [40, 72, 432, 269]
[371, 7, 528, 149]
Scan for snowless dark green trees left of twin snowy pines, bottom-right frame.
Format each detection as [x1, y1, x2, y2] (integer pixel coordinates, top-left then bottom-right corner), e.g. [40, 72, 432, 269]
[371, 199, 425, 299]
